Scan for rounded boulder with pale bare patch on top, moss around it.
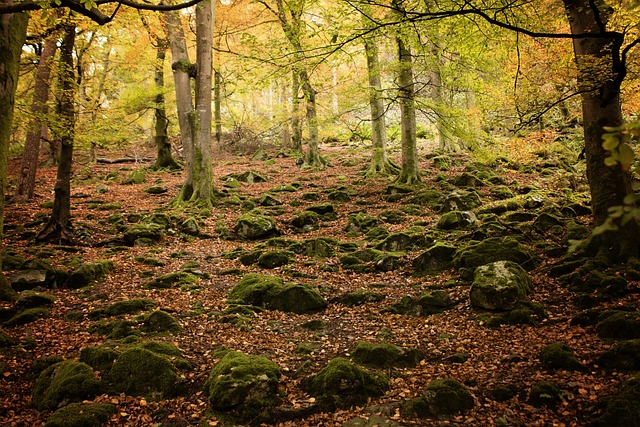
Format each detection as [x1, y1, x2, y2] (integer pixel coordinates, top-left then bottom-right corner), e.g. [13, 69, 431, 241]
[471, 261, 532, 311]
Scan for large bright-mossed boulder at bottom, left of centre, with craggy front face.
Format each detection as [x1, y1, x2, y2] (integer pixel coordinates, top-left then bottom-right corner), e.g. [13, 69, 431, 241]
[204, 351, 281, 419]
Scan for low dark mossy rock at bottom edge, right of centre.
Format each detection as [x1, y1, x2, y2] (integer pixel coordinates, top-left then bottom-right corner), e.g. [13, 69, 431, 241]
[401, 378, 475, 418]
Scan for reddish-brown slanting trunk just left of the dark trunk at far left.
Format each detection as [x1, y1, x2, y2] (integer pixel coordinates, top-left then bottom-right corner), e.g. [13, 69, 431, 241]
[16, 36, 58, 200]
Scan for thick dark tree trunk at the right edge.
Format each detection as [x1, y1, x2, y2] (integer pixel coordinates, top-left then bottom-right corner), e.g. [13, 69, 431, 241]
[564, 0, 640, 261]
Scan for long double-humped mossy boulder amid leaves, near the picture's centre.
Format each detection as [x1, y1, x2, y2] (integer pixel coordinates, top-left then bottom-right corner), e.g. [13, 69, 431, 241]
[229, 273, 327, 313]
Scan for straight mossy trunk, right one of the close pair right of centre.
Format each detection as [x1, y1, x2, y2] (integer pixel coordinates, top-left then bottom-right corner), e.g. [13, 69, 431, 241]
[396, 37, 420, 185]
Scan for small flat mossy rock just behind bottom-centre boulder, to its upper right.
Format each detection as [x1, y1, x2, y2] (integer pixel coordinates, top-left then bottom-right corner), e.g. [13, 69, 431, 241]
[351, 342, 425, 369]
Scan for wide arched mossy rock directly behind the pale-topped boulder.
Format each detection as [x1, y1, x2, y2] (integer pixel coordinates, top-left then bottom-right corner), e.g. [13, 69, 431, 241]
[453, 237, 538, 272]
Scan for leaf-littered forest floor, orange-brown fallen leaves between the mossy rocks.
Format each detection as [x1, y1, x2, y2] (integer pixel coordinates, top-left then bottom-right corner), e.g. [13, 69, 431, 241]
[0, 139, 637, 427]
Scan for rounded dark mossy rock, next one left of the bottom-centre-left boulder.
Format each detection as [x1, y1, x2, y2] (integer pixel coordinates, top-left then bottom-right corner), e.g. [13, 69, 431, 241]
[107, 347, 186, 400]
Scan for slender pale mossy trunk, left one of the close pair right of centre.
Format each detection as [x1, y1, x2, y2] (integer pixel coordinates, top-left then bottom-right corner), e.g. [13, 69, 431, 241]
[364, 37, 399, 177]
